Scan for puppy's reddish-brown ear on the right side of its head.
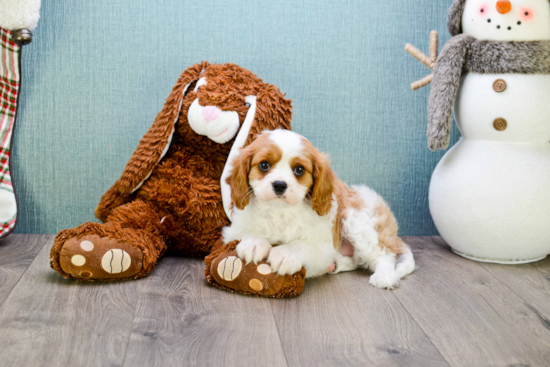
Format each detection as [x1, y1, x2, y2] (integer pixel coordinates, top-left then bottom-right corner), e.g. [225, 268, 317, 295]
[311, 151, 336, 216]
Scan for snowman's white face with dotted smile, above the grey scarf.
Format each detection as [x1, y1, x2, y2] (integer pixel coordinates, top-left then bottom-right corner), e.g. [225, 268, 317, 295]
[462, 0, 550, 41]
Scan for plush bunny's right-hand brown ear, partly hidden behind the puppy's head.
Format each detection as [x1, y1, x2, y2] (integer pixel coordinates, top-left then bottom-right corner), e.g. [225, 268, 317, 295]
[246, 84, 292, 145]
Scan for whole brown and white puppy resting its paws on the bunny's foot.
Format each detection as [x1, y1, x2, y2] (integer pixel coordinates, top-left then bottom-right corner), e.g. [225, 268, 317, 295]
[222, 130, 415, 289]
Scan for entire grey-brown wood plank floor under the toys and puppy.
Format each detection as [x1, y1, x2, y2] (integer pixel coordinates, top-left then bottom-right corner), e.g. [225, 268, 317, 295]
[0, 235, 550, 367]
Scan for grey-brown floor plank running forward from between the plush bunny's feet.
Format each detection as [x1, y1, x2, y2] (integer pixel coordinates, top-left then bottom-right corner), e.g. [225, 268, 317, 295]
[124, 258, 286, 367]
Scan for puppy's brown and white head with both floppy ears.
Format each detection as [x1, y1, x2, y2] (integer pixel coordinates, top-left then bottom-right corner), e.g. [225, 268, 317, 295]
[228, 130, 335, 216]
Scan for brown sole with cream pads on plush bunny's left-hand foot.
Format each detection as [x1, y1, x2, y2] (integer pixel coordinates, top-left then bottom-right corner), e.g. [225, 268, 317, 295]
[54, 235, 143, 280]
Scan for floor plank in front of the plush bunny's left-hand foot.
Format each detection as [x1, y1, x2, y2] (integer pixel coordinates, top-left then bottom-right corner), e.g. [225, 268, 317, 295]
[0, 239, 142, 366]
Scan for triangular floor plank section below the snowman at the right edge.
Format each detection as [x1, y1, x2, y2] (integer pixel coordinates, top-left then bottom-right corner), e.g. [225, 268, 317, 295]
[481, 257, 550, 327]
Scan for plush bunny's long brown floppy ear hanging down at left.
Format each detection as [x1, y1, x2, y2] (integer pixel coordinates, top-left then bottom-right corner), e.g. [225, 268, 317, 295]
[116, 61, 210, 195]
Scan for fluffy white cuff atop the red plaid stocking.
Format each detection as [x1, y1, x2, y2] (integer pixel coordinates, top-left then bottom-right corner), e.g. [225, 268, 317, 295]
[0, 0, 40, 31]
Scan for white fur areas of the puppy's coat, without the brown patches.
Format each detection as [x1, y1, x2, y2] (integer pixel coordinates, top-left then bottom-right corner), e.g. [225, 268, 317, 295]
[223, 130, 415, 289]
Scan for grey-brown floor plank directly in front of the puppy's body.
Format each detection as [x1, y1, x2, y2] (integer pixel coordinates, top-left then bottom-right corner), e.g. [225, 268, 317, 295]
[271, 271, 448, 366]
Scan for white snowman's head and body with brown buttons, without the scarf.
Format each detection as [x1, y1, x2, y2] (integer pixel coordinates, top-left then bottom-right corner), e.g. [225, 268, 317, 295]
[429, 0, 550, 263]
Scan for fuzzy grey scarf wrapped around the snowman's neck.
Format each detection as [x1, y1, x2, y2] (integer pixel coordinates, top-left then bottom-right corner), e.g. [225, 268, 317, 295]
[428, 34, 550, 150]
